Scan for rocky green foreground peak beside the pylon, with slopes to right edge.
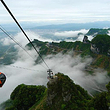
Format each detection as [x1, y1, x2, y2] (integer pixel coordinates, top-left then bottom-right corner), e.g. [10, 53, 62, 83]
[30, 74, 110, 110]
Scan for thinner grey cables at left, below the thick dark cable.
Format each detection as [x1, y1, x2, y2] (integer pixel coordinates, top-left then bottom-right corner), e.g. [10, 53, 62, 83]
[0, 25, 46, 69]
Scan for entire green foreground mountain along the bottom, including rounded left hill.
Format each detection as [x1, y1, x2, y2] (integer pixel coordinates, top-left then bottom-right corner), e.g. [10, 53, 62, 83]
[2, 73, 110, 110]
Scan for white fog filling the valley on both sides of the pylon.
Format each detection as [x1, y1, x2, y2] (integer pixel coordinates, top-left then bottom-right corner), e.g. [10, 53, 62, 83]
[0, 31, 109, 103]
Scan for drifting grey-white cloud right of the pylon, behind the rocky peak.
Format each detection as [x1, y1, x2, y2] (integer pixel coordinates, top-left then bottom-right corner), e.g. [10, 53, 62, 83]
[46, 52, 110, 93]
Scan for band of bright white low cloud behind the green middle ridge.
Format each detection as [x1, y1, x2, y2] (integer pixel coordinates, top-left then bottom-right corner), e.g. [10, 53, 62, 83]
[0, 29, 93, 47]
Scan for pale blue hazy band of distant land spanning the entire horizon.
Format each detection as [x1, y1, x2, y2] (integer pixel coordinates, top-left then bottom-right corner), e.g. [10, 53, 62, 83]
[2, 21, 110, 34]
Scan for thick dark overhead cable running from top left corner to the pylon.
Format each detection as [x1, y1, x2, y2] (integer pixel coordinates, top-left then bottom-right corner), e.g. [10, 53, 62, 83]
[1, 0, 49, 69]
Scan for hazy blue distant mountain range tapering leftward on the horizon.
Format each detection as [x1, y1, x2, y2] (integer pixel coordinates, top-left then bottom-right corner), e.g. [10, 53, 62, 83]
[31, 21, 110, 31]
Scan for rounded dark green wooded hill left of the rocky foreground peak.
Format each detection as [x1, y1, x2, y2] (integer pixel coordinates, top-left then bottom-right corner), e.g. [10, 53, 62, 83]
[7, 84, 46, 110]
